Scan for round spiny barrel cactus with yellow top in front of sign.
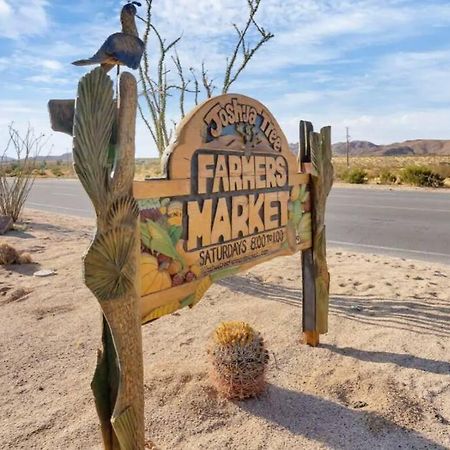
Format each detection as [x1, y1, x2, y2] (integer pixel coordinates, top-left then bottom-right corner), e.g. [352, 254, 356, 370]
[208, 322, 269, 400]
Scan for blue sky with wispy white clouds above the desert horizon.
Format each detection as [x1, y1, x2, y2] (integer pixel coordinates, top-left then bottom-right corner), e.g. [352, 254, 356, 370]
[0, 0, 450, 157]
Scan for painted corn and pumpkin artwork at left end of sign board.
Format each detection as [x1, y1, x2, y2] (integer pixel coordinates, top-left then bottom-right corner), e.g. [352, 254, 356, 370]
[139, 198, 200, 296]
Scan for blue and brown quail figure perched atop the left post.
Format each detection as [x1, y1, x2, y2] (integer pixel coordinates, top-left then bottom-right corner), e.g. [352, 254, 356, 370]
[72, 2, 145, 72]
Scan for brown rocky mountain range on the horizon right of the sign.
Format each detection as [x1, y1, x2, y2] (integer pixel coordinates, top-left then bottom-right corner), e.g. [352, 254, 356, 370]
[332, 139, 450, 156]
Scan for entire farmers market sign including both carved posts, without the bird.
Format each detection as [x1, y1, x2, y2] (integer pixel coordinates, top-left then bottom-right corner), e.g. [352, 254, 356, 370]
[49, 68, 333, 450]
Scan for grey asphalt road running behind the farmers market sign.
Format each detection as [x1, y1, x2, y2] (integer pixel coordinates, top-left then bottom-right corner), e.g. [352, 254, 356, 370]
[26, 179, 450, 264]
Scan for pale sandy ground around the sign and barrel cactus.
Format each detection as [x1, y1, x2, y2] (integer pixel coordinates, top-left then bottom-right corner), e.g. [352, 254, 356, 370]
[0, 210, 450, 450]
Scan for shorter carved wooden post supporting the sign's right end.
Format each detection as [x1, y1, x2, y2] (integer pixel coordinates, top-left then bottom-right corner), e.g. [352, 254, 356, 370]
[299, 120, 333, 346]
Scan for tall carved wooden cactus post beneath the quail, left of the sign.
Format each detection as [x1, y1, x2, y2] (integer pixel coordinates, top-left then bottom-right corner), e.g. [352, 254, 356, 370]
[73, 68, 144, 450]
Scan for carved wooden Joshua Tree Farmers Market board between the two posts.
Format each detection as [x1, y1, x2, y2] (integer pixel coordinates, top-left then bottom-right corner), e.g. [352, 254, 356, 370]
[134, 94, 312, 323]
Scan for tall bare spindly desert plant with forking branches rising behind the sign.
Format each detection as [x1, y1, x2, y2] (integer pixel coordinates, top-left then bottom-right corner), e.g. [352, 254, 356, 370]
[139, 0, 274, 156]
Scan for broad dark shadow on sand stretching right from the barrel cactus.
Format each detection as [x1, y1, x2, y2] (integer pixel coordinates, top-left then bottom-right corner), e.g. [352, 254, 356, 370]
[237, 385, 445, 450]
